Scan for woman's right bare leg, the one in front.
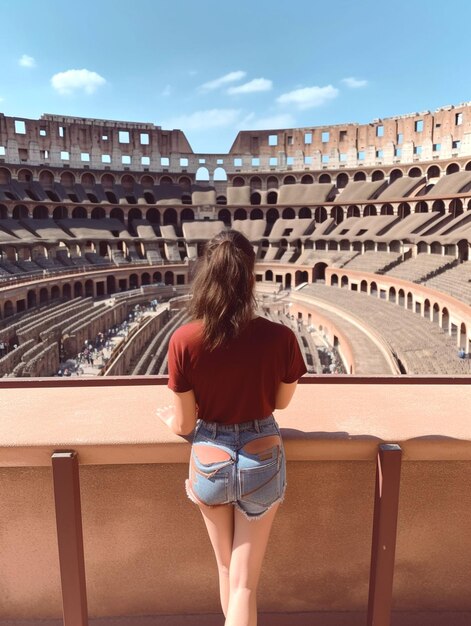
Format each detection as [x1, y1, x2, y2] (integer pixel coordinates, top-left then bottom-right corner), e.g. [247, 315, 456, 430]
[225, 504, 278, 626]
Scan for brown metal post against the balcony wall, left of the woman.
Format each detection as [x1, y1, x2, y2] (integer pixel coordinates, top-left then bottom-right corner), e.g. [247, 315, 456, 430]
[52, 451, 88, 626]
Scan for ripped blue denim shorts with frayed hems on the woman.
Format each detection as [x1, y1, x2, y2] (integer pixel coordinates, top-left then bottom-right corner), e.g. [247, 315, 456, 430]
[186, 415, 286, 519]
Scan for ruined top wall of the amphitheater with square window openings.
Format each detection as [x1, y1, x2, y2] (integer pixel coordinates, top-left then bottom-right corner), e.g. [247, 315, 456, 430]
[0, 103, 471, 180]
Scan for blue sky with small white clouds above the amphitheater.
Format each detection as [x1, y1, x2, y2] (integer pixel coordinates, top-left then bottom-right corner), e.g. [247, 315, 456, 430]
[0, 0, 471, 152]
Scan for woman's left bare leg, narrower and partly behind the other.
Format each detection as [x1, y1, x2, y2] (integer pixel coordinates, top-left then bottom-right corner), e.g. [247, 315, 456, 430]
[199, 503, 234, 617]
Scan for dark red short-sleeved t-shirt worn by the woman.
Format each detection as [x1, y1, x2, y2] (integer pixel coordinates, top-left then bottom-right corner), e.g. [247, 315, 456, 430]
[168, 317, 307, 424]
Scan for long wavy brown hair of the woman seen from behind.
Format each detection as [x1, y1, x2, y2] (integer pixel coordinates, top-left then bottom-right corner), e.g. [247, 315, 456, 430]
[190, 230, 255, 350]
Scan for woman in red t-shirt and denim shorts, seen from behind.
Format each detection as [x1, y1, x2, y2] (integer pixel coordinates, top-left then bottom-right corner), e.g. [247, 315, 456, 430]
[160, 230, 306, 626]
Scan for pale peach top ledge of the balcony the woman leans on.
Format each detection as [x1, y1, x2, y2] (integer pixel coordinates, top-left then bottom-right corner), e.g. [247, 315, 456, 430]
[0, 376, 471, 467]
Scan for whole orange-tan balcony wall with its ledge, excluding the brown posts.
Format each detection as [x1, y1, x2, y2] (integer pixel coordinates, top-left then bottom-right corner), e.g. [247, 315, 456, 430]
[0, 376, 471, 626]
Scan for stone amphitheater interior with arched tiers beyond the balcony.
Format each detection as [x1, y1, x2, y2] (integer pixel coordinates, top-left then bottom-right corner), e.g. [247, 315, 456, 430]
[0, 103, 471, 376]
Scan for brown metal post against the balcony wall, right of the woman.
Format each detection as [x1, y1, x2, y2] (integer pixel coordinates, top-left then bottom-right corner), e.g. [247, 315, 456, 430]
[367, 443, 402, 626]
